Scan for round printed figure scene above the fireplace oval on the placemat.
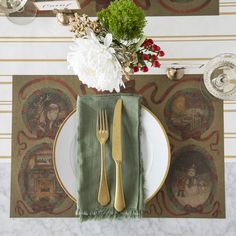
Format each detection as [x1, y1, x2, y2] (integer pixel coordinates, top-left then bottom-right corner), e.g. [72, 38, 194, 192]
[22, 88, 73, 138]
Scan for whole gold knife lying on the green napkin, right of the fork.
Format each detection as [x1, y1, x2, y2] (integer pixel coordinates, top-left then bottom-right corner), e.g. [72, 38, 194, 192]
[112, 99, 125, 212]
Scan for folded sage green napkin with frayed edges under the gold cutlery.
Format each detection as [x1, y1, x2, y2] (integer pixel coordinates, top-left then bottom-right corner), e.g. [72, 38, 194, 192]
[76, 94, 144, 221]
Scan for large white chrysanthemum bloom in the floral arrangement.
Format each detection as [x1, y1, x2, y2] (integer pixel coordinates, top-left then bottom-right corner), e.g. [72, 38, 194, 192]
[67, 31, 124, 92]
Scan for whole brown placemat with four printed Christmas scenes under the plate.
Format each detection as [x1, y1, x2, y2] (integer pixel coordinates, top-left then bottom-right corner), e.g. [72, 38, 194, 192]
[11, 75, 225, 218]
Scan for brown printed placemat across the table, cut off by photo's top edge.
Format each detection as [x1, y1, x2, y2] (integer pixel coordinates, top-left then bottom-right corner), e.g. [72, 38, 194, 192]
[76, 0, 219, 16]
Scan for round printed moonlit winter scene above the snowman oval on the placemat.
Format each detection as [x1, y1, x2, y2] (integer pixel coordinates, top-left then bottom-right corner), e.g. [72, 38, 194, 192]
[164, 88, 214, 140]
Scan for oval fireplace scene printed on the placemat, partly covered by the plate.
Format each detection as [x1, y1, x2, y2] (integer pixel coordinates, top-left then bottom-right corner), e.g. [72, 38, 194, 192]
[18, 143, 67, 212]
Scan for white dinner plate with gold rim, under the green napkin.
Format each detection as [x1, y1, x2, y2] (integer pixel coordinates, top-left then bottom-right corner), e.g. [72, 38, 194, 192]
[53, 107, 170, 202]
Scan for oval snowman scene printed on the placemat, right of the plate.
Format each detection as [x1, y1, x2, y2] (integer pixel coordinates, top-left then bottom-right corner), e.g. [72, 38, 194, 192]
[168, 145, 217, 211]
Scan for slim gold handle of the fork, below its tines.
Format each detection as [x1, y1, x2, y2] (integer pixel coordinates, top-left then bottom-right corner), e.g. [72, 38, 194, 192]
[98, 144, 110, 206]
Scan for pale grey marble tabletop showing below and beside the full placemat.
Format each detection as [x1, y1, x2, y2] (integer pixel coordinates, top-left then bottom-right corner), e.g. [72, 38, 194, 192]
[0, 163, 236, 236]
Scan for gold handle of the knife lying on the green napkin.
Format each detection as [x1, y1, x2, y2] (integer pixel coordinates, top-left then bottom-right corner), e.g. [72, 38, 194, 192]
[114, 162, 125, 212]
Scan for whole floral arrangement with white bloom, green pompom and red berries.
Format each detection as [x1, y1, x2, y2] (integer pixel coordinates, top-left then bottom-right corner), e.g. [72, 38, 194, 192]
[67, 0, 165, 92]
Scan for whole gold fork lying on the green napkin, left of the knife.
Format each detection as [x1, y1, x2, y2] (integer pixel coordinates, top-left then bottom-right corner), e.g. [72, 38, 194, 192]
[96, 110, 110, 206]
